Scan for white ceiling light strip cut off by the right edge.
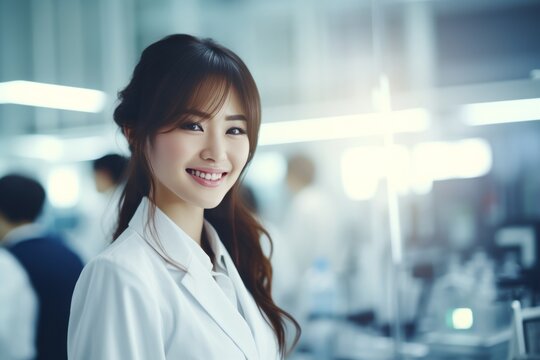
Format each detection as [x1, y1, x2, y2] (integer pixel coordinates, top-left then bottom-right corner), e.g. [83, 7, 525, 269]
[462, 98, 540, 126]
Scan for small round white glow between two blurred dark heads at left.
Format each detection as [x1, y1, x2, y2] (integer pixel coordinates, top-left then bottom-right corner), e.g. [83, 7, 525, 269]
[47, 167, 80, 208]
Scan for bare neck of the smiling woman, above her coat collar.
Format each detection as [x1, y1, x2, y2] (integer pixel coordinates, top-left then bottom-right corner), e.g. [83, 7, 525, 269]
[155, 188, 204, 245]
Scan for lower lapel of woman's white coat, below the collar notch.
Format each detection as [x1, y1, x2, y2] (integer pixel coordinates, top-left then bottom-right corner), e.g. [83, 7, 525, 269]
[181, 255, 259, 360]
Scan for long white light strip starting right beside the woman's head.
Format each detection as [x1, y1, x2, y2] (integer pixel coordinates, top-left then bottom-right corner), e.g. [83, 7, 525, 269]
[259, 108, 429, 145]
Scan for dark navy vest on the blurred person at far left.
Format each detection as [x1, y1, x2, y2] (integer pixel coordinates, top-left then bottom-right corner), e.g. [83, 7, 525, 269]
[7, 235, 83, 360]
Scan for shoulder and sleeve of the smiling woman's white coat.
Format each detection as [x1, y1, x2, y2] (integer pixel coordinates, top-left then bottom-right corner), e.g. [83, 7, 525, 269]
[68, 229, 167, 359]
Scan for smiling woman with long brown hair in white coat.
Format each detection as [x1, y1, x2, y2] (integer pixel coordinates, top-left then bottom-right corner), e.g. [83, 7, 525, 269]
[68, 35, 299, 360]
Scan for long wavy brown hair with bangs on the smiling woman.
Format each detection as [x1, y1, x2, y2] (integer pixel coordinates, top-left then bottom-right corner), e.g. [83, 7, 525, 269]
[113, 35, 300, 356]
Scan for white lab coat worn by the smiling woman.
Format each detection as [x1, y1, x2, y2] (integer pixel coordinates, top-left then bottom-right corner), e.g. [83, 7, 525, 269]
[68, 198, 279, 360]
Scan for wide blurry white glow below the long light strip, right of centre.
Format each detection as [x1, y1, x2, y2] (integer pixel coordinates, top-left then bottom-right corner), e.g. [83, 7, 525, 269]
[341, 138, 493, 200]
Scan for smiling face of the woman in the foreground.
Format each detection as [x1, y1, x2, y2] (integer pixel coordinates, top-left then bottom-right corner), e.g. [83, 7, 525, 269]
[148, 89, 249, 209]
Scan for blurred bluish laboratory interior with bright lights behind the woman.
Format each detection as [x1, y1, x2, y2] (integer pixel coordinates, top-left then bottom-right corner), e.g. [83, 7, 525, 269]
[0, 0, 540, 360]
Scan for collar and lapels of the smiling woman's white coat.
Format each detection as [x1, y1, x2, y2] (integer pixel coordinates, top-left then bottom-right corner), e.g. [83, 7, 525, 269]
[129, 197, 259, 360]
